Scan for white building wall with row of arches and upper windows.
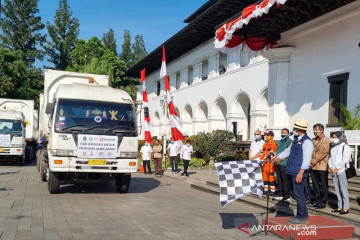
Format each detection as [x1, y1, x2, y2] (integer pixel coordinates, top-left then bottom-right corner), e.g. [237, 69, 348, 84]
[138, 1, 360, 140]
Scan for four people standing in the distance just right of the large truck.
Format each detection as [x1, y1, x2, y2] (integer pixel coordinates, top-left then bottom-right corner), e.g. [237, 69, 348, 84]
[140, 138, 194, 177]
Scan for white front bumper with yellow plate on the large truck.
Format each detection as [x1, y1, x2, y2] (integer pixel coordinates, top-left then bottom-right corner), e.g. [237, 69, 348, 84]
[48, 157, 138, 173]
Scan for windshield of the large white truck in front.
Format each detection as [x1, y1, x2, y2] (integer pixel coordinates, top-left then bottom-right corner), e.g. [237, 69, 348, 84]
[55, 99, 135, 133]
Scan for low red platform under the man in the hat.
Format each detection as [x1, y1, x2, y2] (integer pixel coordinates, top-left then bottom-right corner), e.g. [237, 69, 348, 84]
[262, 216, 355, 240]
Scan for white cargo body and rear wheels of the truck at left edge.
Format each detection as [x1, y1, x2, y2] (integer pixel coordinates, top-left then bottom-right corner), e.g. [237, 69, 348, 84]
[0, 98, 39, 162]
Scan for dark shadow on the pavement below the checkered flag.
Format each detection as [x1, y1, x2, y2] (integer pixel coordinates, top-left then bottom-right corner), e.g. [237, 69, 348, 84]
[220, 213, 259, 229]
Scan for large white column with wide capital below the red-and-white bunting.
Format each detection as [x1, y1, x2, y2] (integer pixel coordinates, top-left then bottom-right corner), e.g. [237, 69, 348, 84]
[262, 47, 295, 135]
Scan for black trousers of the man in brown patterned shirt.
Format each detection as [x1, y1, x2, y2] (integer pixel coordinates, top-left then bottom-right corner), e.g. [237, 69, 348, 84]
[310, 170, 329, 204]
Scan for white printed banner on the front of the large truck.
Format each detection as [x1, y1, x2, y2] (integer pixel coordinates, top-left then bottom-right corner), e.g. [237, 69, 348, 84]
[78, 134, 118, 158]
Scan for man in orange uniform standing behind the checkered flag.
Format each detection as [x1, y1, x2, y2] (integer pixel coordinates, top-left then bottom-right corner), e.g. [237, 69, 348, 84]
[260, 131, 277, 196]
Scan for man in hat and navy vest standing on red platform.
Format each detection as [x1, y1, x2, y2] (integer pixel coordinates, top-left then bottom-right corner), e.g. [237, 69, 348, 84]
[273, 119, 314, 224]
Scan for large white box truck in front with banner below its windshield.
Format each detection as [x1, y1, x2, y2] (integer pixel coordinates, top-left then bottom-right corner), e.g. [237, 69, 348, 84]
[38, 69, 138, 193]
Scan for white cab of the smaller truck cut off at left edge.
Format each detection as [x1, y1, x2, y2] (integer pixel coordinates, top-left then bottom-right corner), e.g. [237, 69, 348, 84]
[0, 110, 25, 166]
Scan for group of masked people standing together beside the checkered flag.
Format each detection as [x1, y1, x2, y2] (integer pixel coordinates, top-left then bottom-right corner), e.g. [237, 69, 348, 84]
[249, 119, 351, 224]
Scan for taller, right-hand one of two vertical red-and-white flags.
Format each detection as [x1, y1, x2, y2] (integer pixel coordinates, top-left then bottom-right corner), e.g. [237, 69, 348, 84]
[160, 45, 185, 142]
